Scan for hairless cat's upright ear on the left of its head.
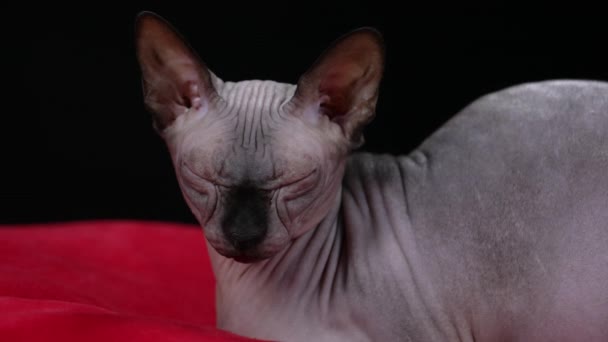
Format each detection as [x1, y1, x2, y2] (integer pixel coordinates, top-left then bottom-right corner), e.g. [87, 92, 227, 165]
[135, 12, 219, 130]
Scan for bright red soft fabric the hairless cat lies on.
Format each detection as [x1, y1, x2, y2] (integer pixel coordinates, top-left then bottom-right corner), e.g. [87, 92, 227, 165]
[0, 221, 266, 342]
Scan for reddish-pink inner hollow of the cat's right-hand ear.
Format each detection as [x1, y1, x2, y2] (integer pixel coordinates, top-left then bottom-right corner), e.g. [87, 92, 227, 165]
[319, 61, 363, 119]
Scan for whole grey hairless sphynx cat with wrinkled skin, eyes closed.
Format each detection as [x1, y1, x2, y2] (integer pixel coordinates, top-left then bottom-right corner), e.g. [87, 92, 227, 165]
[136, 12, 608, 342]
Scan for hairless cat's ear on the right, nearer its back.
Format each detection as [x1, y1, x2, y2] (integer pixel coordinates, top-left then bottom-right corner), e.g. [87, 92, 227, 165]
[292, 28, 384, 146]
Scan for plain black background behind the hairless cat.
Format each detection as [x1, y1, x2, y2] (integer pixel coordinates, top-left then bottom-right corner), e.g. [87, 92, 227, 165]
[0, 1, 608, 223]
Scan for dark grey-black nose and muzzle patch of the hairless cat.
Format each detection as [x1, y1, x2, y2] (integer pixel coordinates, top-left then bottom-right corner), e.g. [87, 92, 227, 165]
[222, 185, 270, 251]
